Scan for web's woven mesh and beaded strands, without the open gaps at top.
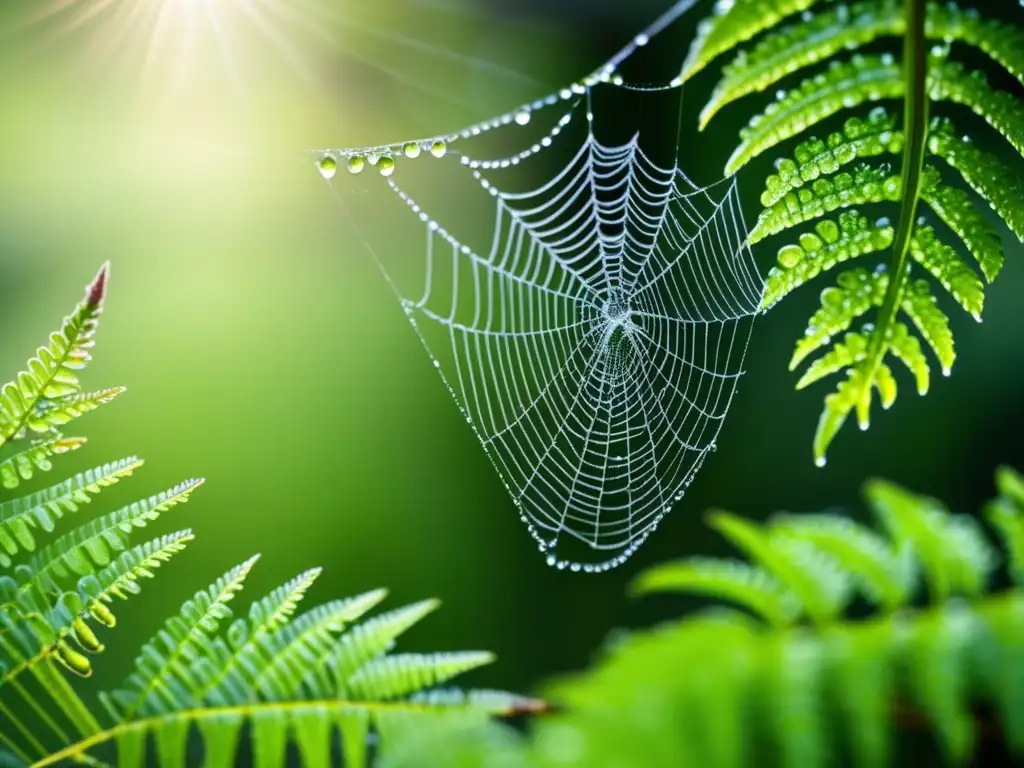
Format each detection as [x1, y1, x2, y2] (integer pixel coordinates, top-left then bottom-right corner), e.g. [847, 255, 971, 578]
[317, 2, 763, 572]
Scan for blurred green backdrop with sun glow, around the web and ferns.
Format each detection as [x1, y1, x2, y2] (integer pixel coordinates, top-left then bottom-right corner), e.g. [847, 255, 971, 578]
[0, 0, 1024, 704]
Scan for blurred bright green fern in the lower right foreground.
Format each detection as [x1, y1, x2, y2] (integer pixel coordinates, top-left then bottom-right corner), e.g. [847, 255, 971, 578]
[442, 469, 1024, 768]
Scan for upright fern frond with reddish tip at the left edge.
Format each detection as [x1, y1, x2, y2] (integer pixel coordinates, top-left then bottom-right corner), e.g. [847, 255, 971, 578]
[0, 264, 109, 445]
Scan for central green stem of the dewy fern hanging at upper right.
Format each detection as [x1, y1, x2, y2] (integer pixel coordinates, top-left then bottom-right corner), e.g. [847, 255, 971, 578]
[865, 0, 928, 378]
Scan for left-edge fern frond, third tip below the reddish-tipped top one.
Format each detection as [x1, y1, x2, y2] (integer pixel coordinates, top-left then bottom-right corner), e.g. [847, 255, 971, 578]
[0, 457, 142, 567]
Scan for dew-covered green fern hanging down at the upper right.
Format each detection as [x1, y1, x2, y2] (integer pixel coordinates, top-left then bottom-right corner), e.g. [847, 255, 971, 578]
[682, 0, 1024, 465]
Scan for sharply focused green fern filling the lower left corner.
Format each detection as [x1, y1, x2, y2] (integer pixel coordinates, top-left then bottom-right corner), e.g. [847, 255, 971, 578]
[0, 267, 539, 766]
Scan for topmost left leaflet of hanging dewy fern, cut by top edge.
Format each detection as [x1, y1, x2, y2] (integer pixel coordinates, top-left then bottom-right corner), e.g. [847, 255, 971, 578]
[681, 0, 816, 80]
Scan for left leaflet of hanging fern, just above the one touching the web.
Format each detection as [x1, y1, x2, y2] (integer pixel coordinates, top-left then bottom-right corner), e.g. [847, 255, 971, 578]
[750, 163, 903, 241]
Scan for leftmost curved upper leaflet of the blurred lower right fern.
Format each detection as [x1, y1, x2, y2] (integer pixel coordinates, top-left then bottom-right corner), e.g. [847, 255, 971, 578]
[631, 557, 801, 627]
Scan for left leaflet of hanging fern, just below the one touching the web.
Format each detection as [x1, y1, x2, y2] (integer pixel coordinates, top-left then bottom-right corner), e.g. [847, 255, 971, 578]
[790, 268, 889, 371]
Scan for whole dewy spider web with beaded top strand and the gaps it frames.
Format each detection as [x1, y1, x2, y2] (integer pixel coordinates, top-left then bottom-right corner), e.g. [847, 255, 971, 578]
[314, 0, 763, 571]
